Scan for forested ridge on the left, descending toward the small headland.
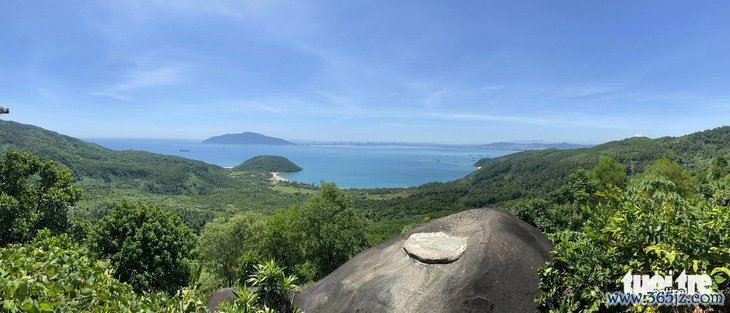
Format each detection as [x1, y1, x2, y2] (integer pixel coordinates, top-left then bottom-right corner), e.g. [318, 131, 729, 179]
[0, 120, 232, 194]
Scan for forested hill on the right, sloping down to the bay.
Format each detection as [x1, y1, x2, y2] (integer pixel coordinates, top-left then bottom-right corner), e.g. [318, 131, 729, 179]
[370, 126, 730, 215]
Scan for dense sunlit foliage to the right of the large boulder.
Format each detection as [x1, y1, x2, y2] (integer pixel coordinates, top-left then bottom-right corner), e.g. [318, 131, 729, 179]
[537, 175, 730, 312]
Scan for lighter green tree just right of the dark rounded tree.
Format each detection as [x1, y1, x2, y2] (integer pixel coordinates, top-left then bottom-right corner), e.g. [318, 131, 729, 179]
[198, 212, 266, 286]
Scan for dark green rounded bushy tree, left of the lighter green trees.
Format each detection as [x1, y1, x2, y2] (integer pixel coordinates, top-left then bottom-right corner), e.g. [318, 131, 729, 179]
[88, 202, 195, 293]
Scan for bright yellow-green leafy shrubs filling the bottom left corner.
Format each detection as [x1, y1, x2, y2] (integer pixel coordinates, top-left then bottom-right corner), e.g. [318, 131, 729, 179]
[0, 231, 205, 313]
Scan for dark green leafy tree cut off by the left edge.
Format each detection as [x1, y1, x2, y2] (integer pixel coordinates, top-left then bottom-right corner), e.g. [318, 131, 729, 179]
[0, 150, 81, 246]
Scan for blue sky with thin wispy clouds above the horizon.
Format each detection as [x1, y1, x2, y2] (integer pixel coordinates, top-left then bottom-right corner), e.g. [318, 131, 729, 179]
[0, 0, 730, 143]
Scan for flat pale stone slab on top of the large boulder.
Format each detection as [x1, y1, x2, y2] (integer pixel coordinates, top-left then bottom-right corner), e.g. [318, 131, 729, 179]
[403, 232, 467, 264]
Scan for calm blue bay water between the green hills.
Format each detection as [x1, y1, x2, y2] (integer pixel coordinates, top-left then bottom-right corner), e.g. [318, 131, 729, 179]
[86, 139, 514, 188]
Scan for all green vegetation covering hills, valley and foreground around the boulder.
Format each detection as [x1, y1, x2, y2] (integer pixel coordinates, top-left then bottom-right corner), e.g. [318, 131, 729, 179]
[0, 121, 730, 312]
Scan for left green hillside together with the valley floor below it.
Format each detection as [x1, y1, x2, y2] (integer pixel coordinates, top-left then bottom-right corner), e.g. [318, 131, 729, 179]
[0, 120, 306, 230]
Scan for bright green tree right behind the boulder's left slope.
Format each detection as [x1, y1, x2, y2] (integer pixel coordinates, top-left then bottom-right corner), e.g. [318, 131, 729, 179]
[267, 182, 368, 281]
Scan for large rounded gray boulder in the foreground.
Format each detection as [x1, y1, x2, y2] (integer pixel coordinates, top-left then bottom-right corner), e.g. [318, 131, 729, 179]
[294, 209, 552, 313]
